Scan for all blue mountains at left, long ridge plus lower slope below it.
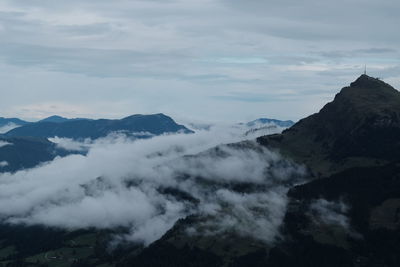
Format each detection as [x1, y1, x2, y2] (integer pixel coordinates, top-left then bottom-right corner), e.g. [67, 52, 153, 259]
[0, 114, 193, 173]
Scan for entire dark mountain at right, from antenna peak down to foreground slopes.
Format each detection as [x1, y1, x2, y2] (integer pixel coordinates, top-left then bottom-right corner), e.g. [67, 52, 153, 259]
[122, 75, 400, 267]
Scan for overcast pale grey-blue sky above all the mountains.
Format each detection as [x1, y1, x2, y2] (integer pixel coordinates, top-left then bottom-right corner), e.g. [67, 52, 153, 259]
[0, 0, 400, 121]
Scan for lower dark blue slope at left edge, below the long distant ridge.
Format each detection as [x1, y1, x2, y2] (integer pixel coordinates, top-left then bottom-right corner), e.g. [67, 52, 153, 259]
[0, 136, 76, 173]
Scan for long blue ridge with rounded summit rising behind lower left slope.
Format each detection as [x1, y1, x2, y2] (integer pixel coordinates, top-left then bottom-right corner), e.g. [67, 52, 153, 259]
[5, 114, 192, 139]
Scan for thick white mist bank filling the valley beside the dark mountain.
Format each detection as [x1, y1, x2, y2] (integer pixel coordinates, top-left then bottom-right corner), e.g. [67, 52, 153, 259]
[0, 128, 304, 244]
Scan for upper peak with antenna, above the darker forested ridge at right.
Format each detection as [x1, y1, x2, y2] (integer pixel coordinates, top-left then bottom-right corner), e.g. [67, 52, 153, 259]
[258, 75, 400, 176]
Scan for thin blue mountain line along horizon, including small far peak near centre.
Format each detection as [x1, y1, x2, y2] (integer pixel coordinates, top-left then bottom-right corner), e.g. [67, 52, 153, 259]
[0, 114, 294, 139]
